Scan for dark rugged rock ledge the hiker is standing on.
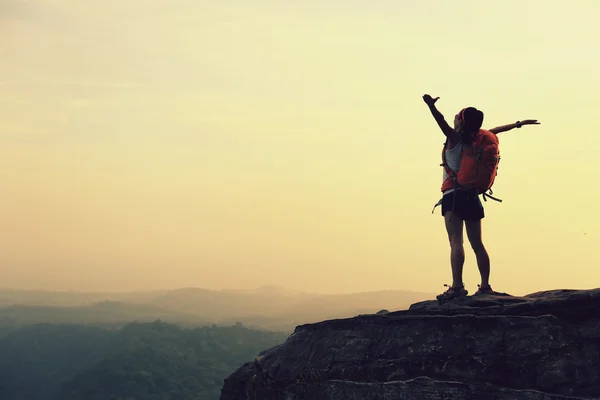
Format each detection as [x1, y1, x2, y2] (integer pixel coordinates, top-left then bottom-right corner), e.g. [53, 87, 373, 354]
[221, 289, 600, 400]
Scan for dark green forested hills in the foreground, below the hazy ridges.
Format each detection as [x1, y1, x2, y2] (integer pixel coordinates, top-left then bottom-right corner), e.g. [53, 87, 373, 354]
[0, 321, 287, 400]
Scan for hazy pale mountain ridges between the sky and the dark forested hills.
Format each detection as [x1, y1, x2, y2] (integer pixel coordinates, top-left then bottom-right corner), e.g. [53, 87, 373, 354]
[0, 286, 434, 331]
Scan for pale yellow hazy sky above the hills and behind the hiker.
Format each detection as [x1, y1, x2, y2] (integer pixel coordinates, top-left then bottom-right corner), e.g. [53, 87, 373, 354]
[0, 0, 600, 295]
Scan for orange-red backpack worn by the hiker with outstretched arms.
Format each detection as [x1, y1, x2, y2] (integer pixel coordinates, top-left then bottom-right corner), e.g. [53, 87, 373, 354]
[442, 129, 502, 201]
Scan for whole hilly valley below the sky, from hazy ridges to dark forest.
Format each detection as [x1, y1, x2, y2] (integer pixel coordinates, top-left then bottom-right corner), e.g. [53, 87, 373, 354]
[0, 286, 434, 400]
